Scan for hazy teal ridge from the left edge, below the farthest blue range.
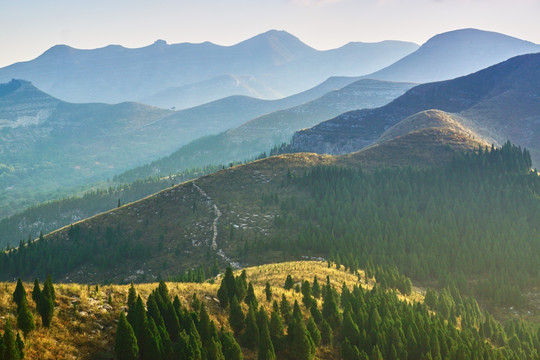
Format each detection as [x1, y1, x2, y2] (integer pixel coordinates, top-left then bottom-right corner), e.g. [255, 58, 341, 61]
[0, 77, 368, 216]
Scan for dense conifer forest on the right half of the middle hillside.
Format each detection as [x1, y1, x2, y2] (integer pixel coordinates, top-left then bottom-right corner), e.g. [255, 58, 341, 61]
[266, 143, 540, 305]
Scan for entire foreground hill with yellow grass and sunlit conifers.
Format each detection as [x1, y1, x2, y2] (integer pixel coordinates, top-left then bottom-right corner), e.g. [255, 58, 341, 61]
[0, 261, 540, 360]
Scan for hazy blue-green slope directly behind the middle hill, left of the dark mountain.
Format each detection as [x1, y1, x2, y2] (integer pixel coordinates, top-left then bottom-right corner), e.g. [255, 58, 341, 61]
[118, 78, 413, 181]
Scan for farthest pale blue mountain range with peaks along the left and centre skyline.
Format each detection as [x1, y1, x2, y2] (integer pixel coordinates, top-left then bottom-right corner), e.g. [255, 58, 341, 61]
[0, 30, 418, 107]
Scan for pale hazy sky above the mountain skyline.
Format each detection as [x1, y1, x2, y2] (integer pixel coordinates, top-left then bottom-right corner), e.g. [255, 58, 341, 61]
[0, 0, 540, 66]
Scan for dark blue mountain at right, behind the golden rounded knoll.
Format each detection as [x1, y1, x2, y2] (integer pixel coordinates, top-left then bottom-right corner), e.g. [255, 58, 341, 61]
[291, 53, 540, 164]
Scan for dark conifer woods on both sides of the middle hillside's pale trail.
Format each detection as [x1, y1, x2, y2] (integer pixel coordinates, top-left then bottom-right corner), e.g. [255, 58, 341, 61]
[0, 143, 540, 306]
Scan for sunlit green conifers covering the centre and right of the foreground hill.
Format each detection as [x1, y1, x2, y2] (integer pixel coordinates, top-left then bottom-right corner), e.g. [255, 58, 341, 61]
[115, 267, 540, 360]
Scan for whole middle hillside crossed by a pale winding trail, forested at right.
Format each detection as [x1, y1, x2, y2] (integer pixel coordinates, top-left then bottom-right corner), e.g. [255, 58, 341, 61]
[0, 143, 540, 318]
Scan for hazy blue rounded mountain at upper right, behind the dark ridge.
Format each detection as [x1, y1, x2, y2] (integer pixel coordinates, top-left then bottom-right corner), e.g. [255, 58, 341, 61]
[367, 29, 540, 83]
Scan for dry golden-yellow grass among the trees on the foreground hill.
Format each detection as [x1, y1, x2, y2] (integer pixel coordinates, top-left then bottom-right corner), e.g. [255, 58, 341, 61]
[0, 261, 423, 360]
